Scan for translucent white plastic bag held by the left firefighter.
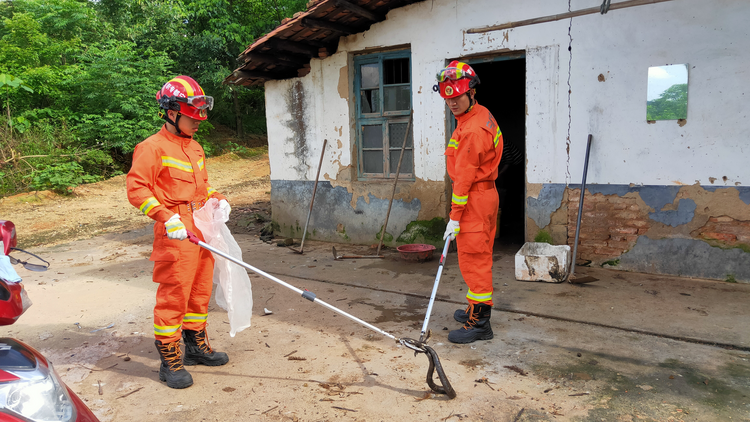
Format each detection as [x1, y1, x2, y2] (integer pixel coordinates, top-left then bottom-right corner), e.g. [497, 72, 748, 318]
[193, 198, 253, 337]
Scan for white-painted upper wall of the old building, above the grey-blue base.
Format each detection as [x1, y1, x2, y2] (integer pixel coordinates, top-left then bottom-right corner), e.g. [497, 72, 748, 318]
[266, 0, 750, 186]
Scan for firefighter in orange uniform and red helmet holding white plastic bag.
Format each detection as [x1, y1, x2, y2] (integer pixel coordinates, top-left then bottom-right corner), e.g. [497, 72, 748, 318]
[127, 76, 231, 388]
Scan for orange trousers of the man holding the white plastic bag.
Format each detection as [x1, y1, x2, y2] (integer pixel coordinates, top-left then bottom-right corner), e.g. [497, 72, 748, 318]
[153, 218, 214, 343]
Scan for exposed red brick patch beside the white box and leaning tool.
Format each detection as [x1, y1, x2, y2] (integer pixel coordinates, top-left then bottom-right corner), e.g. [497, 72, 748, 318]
[568, 189, 650, 263]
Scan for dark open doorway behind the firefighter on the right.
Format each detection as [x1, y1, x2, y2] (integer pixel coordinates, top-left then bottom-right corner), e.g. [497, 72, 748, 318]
[467, 55, 526, 245]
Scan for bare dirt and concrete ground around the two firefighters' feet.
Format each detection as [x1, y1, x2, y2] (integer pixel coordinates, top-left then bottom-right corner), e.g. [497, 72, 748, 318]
[0, 155, 750, 422]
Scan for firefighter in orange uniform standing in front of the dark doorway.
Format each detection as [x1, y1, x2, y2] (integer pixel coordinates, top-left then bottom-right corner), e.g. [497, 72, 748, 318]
[434, 60, 503, 343]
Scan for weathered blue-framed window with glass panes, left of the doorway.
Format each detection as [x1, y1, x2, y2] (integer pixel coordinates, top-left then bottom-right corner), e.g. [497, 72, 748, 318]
[354, 50, 414, 179]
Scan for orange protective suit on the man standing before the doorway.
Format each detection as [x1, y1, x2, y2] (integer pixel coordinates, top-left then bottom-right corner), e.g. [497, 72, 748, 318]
[445, 103, 503, 306]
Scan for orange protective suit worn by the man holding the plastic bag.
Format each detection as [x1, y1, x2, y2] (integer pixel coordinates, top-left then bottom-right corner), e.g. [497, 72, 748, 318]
[127, 127, 226, 344]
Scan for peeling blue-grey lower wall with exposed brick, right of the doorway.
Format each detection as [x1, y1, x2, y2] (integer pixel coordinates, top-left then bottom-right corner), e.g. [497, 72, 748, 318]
[527, 184, 750, 282]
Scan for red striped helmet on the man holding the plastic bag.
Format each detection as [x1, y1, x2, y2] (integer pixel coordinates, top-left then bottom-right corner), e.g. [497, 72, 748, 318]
[156, 75, 214, 120]
